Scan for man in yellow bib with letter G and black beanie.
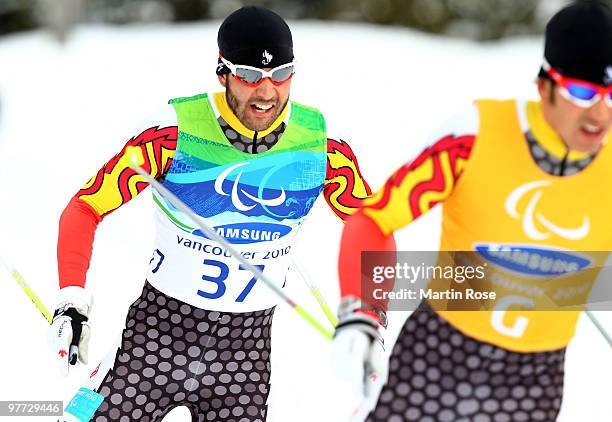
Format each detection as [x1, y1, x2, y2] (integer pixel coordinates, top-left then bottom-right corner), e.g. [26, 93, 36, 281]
[334, 1, 612, 422]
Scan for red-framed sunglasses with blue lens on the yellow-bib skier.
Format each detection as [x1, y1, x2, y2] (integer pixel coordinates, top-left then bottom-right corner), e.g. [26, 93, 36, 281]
[542, 60, 612, 108]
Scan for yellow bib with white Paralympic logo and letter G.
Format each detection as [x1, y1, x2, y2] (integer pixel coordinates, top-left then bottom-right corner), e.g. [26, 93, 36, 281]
[434, 100, 612, 352]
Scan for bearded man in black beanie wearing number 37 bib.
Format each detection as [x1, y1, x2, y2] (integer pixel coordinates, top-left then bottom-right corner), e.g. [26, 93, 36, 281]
[55, 6, 370, 422]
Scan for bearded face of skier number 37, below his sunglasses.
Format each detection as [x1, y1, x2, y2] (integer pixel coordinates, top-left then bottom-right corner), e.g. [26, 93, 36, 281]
[219, 69, 291, 132]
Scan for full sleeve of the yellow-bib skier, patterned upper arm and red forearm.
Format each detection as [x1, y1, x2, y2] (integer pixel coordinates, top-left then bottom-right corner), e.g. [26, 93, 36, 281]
[338, 135, 475, 309]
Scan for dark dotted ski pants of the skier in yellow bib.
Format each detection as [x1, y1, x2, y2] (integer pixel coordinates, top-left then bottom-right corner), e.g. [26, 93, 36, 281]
[367, 303, 565, 422]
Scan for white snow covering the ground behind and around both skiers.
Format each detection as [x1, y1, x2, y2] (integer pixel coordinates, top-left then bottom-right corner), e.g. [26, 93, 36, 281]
[0, 22, 612, 422]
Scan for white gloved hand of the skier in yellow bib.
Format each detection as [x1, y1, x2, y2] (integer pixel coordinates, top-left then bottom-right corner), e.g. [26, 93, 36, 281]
[332, 298, 388, 399]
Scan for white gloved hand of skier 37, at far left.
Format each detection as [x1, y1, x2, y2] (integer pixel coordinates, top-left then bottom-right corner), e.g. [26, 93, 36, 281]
[48, 286, 91, 376]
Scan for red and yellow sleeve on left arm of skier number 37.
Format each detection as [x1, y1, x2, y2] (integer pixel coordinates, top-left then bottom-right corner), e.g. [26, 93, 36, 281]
[57, 126, 178, 287]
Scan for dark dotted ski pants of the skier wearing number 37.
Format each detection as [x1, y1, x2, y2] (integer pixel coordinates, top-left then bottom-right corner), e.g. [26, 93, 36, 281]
[84, 282, 274, 422]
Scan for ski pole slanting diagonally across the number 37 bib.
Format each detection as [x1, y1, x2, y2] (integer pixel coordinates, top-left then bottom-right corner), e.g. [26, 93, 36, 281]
[124, 147, 333, 340]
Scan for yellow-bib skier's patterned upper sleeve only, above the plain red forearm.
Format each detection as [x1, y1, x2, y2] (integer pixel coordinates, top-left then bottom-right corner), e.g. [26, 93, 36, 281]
[363, 135, 475, 235]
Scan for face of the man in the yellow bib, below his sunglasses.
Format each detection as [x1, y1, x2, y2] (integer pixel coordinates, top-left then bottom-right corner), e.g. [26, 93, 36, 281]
[538, 79, 612, 152]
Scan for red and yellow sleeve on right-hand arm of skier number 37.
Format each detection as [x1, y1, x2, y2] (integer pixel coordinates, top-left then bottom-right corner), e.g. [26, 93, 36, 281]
[323, 139, 372, 221]
